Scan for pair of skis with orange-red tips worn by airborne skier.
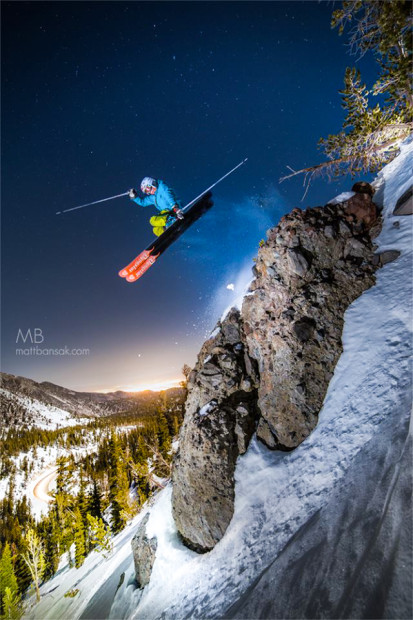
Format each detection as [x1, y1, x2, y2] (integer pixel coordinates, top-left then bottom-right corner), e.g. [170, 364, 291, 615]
[119, 192, 213, 282]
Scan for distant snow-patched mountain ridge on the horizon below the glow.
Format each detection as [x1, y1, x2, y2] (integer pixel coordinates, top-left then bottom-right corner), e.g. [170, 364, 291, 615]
[0, 373, 183, 426]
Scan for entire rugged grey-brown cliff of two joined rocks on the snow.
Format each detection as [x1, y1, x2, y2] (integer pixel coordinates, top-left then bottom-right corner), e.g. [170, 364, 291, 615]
[169, 184, 380, 552]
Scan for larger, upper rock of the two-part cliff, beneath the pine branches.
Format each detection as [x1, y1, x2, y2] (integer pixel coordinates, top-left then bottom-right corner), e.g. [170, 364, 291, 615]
[242, 201, 379, 449]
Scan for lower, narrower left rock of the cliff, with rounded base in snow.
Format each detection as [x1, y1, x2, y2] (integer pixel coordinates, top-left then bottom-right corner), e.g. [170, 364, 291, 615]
[172, 309, 258, 552]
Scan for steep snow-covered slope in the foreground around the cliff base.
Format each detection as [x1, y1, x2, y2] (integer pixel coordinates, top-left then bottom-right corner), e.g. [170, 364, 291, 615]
[30, 143, 413, 620]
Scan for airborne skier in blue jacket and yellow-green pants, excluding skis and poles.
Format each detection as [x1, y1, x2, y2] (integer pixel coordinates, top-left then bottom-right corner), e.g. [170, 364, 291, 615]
[129, 177, 184, 237]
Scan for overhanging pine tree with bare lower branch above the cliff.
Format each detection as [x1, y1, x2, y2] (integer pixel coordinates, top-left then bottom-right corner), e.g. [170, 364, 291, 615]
[281, 0, 413, 189]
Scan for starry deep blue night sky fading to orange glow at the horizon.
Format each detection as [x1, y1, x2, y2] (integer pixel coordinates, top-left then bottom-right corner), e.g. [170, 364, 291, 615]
[2, 2, 374, 391]
